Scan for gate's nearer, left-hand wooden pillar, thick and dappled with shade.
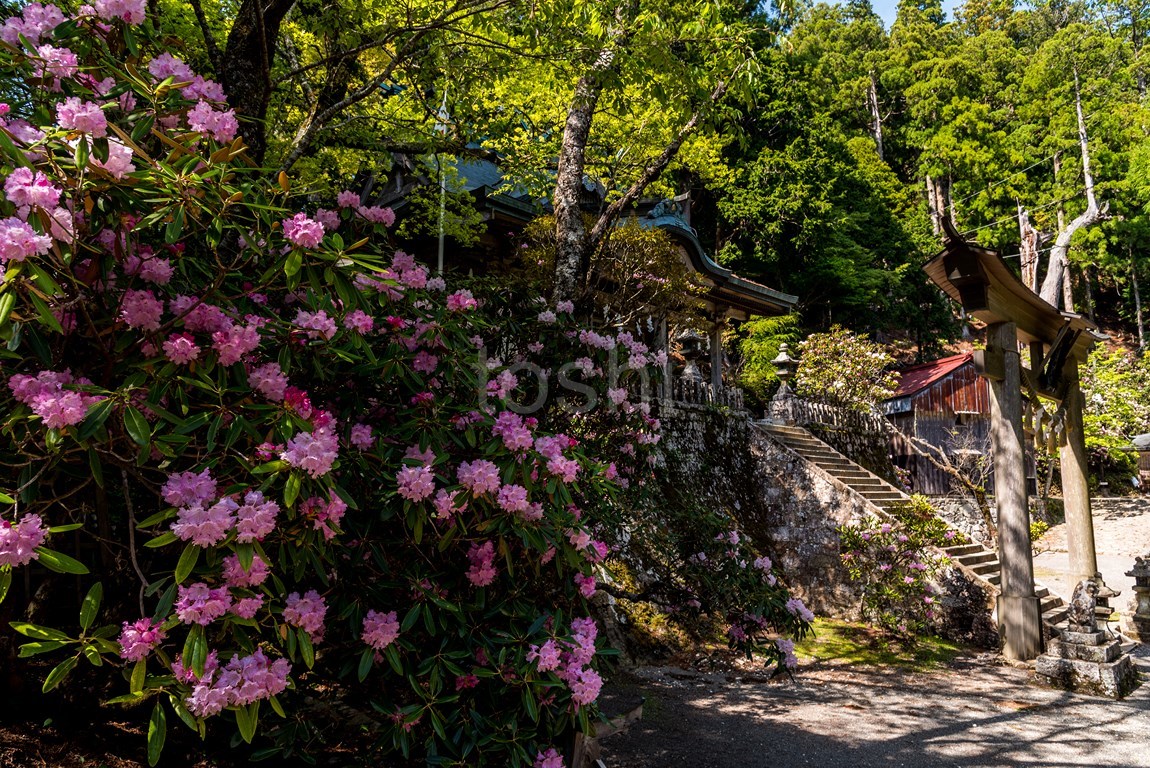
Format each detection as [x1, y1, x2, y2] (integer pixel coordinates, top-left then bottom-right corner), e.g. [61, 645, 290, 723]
[986, 323, 1043, 660]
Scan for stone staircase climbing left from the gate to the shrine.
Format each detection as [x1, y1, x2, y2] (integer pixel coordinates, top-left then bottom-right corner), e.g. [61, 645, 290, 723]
[759, 423, 1067, 630]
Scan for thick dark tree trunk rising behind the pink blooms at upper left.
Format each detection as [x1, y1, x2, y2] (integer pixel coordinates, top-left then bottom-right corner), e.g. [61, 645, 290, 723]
[219, 0, 296, 164]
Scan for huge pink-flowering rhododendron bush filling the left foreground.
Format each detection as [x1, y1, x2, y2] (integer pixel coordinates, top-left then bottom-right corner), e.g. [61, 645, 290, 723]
[0, 7, 806, 767]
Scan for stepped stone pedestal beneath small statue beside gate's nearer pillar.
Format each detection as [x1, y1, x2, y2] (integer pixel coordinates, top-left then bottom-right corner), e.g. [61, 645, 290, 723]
[1034, 630, 1137, 699]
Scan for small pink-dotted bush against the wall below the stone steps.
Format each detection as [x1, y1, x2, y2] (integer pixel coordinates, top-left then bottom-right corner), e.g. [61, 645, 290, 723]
[837, 496, 964, 645]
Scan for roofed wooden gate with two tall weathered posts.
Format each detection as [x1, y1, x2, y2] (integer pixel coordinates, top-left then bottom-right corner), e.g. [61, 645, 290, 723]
[923, 218, 1106, 660]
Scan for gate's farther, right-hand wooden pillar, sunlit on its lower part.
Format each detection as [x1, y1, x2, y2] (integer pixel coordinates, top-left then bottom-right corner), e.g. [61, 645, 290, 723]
[1058, 358, 1098, 586]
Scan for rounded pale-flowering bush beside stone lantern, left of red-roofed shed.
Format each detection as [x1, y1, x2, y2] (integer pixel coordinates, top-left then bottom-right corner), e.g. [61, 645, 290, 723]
[795, 325, 898, 410]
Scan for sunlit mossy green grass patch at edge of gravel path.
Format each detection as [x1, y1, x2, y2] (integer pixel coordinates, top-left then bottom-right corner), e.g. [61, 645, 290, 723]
[795, 619, 969, 671]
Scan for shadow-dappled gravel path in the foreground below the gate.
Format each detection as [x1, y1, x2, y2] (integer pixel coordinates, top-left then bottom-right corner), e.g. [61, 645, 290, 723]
[603, 659, 1150, 768]
